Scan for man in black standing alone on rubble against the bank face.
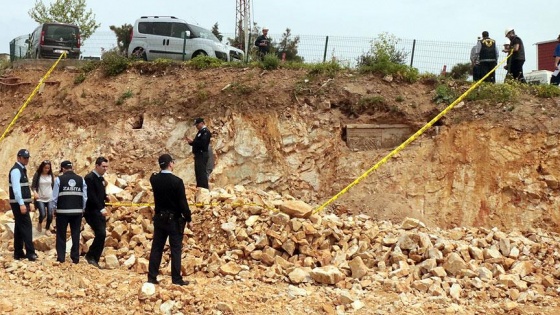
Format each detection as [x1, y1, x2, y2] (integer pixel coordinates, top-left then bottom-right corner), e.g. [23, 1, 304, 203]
[187, 118, 212, 189]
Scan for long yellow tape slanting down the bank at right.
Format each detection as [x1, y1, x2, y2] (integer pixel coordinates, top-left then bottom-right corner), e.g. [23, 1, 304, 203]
[313, 50, 513, 214]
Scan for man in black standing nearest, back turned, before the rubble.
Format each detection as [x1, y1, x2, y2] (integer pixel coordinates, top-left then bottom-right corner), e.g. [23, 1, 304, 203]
[148, 154, 191, 285]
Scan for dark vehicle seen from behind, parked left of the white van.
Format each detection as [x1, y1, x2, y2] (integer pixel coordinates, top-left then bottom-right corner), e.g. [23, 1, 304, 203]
[28, 23, 80, 59]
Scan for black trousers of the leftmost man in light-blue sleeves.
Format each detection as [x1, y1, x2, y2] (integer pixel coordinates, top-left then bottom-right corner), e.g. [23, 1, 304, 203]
[10, 203, 35, 258]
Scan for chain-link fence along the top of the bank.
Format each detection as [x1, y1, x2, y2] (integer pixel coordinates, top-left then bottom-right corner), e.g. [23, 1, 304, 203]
[10, 32, 505, 81]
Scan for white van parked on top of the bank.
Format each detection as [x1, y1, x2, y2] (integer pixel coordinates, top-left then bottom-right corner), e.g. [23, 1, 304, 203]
[128, 16, 244, 61]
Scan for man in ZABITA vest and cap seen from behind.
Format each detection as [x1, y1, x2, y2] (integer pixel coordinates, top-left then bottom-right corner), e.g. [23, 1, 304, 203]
[52, 161, 87, 264]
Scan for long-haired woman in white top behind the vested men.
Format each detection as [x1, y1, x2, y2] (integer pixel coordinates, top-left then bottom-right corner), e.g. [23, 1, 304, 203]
[31, 160, 54, 232]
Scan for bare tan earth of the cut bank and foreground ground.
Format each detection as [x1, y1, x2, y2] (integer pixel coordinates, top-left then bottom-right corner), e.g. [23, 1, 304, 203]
[0, 63, 560, 314]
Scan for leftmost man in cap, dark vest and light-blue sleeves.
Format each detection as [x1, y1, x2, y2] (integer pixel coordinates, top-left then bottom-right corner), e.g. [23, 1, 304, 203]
[8, 149, 37, 261]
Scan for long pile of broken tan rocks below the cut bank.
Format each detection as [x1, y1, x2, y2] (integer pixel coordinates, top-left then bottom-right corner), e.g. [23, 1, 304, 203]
[1, 178, 560, 310]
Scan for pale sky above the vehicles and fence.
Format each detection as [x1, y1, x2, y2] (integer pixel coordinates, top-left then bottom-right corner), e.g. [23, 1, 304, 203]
[0, 0, 560, 72]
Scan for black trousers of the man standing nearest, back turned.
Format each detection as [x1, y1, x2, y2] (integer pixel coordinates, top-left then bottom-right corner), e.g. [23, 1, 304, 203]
[148, 214, 183, 282]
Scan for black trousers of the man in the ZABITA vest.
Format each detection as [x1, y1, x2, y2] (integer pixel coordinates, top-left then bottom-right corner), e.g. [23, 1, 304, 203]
[56, 214, 82, 264]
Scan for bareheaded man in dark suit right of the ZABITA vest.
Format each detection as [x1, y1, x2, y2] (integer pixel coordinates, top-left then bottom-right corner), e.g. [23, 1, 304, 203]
[84, 156, 109, 268]
